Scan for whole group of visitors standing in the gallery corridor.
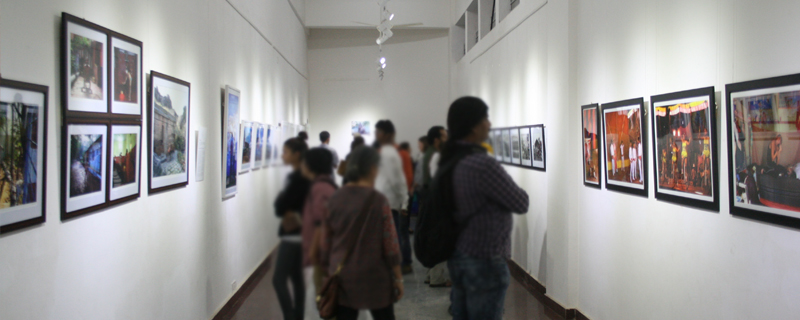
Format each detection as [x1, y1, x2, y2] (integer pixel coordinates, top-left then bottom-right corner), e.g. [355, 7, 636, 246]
[273, 97, 529, 320]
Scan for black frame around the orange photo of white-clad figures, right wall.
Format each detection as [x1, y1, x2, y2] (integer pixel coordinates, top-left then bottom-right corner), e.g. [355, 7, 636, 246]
[600, 98, 649, 198]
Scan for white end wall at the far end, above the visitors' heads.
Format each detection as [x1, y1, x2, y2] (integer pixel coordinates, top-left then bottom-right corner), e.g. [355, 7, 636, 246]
[308, 29, 450, 157]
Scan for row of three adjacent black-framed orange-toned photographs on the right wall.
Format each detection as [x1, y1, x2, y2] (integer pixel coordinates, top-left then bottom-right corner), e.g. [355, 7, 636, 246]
[581, 87, 719, 211]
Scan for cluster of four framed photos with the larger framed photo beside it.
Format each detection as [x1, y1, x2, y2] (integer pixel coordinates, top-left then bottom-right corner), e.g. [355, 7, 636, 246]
[61, 13, 190, 220]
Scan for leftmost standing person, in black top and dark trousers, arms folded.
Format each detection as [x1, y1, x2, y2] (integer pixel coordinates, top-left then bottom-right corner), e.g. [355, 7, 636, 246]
[272, 138, 309, 320]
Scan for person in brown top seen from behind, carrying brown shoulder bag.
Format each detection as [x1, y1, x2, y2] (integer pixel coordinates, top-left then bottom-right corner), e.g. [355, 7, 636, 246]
[321, 147, 404, 320]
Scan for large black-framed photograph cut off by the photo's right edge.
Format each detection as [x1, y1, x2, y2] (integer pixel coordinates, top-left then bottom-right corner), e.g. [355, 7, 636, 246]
[725, 74, 800, 228]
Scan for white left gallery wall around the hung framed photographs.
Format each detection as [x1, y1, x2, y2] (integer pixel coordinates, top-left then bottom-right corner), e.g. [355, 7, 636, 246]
[0, 0, 308, 319]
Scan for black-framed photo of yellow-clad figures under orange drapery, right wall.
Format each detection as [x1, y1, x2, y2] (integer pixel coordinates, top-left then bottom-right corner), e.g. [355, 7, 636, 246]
[648, 87, 719, 211]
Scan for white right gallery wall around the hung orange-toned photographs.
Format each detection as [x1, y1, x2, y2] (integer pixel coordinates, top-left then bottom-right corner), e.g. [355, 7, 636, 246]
[452, 0, 800, 319]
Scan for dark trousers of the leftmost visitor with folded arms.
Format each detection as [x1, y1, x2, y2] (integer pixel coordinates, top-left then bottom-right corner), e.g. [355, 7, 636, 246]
[272, 241, 306, 320]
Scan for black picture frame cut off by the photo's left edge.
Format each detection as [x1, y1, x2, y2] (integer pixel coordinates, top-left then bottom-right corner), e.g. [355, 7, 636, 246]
[0, 79, 49, 234]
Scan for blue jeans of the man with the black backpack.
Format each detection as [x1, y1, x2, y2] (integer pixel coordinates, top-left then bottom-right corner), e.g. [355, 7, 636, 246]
[447, 251, 510, 320]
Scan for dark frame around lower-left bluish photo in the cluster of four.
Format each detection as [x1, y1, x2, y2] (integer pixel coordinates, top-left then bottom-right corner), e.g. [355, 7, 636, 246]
[59, 118, 111, 221]
